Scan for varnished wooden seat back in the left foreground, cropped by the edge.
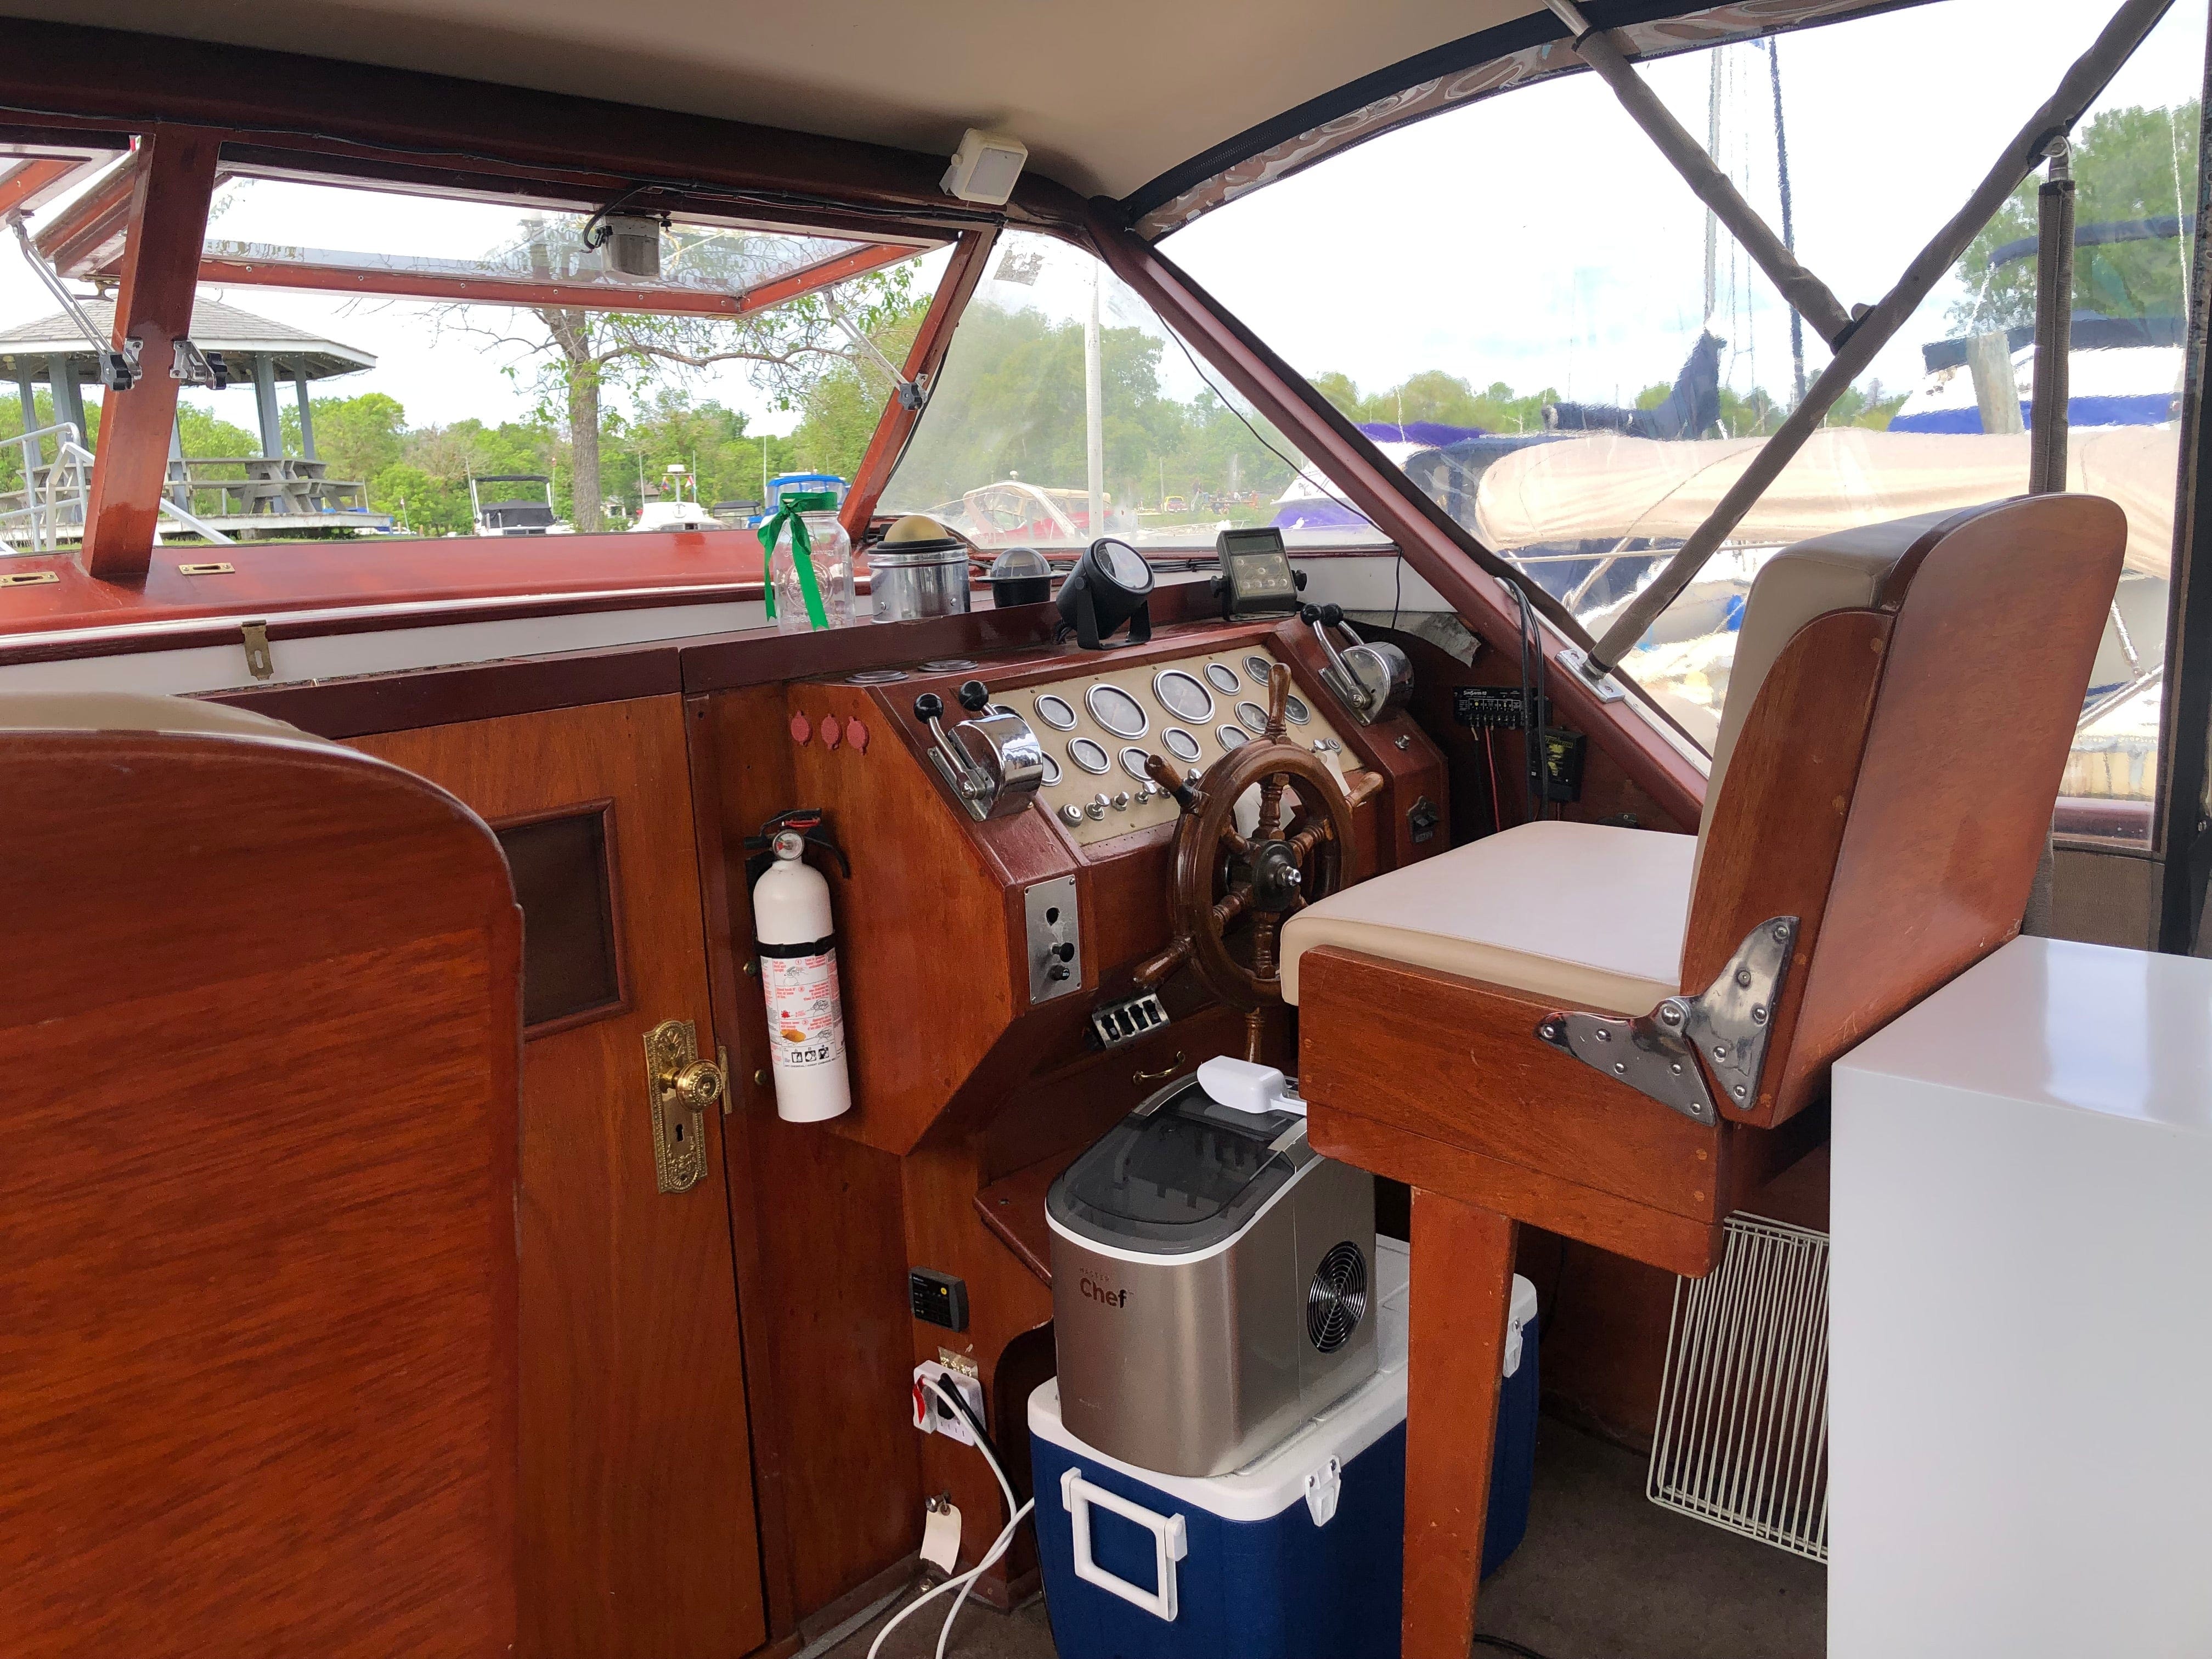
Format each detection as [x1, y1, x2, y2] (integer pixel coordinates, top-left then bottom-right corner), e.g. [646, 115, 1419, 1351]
[0, 695, 520, 1659]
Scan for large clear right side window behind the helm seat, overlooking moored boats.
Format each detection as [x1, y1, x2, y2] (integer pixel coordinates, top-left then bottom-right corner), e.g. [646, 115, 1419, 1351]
[1164, 0, 2205, 836]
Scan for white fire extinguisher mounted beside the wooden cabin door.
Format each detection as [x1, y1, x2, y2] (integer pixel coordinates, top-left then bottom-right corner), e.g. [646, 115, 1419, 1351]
[746, 810, 851, 1124]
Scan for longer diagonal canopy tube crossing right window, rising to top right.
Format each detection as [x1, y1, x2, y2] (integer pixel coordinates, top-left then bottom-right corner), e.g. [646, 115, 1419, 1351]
[1582, 0, 2172, 684]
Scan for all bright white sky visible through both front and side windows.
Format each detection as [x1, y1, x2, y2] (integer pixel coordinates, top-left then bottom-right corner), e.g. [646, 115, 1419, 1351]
[0, 0, 2205, 442]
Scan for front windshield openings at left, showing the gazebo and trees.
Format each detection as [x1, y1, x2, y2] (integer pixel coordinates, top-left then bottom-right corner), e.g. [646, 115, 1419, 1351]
[0, 169, 947, 548]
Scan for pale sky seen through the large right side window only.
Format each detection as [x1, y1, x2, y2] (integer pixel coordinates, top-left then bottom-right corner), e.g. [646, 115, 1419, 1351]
[1164, 0, 2205, 418]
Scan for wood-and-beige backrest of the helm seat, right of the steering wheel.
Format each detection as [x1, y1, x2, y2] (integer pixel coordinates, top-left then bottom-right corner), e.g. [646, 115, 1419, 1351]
[1681, 495, 2128, 1124]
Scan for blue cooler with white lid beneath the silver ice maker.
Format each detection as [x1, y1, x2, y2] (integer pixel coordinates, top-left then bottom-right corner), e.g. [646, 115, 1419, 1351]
[1029, 1239, 1537, 1659]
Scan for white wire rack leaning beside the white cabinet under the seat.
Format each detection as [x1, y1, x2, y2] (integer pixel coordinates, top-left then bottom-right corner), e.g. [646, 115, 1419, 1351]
[1646, 1215, 1827, 1562]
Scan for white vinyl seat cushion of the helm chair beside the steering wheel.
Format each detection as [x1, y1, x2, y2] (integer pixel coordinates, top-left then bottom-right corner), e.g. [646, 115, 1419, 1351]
[1283, 821, 1697, 1013]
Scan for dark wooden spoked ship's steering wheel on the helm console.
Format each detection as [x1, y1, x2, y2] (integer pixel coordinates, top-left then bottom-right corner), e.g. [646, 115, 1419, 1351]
[1135, 664, 1383, 1062]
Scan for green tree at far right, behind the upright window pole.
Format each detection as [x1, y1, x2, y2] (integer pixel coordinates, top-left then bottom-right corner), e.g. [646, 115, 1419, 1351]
[1951, 99, 2199, 334]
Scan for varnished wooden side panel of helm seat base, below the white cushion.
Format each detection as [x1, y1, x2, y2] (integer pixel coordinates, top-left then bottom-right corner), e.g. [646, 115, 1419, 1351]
[1299, 947, 1723, 1243]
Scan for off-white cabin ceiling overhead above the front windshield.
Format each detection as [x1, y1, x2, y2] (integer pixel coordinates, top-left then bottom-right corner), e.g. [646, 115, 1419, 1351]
[0, 0, 1544, 197]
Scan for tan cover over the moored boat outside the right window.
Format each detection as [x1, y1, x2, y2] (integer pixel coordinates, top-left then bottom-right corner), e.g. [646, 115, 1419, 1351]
[1475, 425, 2181, 579]
